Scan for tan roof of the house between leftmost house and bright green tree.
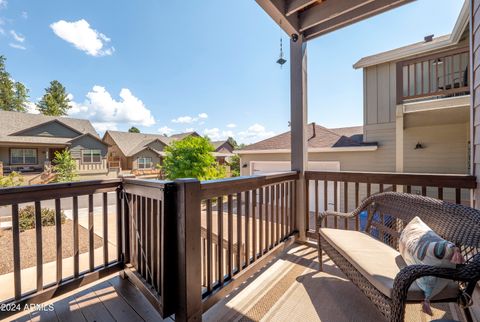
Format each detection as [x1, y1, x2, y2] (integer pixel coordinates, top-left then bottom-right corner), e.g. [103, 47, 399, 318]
[105, 131, 198, 156]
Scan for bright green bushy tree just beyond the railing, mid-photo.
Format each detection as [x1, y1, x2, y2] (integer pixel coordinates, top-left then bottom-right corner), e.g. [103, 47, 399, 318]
[162, 136, 226, 180]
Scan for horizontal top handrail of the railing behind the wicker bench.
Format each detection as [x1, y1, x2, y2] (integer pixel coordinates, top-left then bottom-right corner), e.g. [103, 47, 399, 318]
[305, 171, 477, 189]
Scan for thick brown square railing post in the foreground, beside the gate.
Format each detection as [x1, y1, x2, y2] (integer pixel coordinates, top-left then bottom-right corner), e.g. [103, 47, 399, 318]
[175, 179, 202, 321]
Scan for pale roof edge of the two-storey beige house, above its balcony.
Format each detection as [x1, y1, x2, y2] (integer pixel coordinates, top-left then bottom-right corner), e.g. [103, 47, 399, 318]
[353, 0, 469, 69]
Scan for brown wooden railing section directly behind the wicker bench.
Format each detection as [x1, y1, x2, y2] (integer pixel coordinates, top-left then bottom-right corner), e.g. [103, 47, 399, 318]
[305, 171, 476, 239]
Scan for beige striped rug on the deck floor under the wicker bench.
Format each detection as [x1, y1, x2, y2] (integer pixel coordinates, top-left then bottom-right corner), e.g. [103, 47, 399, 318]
[203, 244, 470, 322]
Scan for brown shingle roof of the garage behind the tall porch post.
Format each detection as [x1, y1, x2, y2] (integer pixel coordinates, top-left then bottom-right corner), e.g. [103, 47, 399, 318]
[237, 123, 376, 154]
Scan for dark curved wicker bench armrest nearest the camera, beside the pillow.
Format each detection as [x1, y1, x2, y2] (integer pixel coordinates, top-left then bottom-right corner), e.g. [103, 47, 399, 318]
[392, 253, 480, 306]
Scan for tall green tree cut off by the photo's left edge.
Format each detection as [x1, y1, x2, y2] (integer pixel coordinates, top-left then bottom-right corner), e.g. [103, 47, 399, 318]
[0, 56, 28, 112]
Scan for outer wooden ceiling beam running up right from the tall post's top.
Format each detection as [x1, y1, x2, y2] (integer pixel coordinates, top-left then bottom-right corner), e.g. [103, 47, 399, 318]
[304, 0, 415, 40]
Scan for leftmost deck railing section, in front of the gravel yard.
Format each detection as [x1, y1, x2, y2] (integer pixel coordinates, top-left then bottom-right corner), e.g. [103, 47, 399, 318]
[0, 179, 123, 319]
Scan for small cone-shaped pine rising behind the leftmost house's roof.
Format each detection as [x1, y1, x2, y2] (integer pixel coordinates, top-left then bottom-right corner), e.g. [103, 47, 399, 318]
[37, 80, 71, 116]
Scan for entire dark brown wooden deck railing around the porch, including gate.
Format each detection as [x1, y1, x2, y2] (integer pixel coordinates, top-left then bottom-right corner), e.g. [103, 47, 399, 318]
[0, 171, 475, 321]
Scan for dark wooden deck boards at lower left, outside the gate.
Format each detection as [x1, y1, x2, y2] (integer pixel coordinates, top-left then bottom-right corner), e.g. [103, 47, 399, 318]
[9, 274, 173, 322]
